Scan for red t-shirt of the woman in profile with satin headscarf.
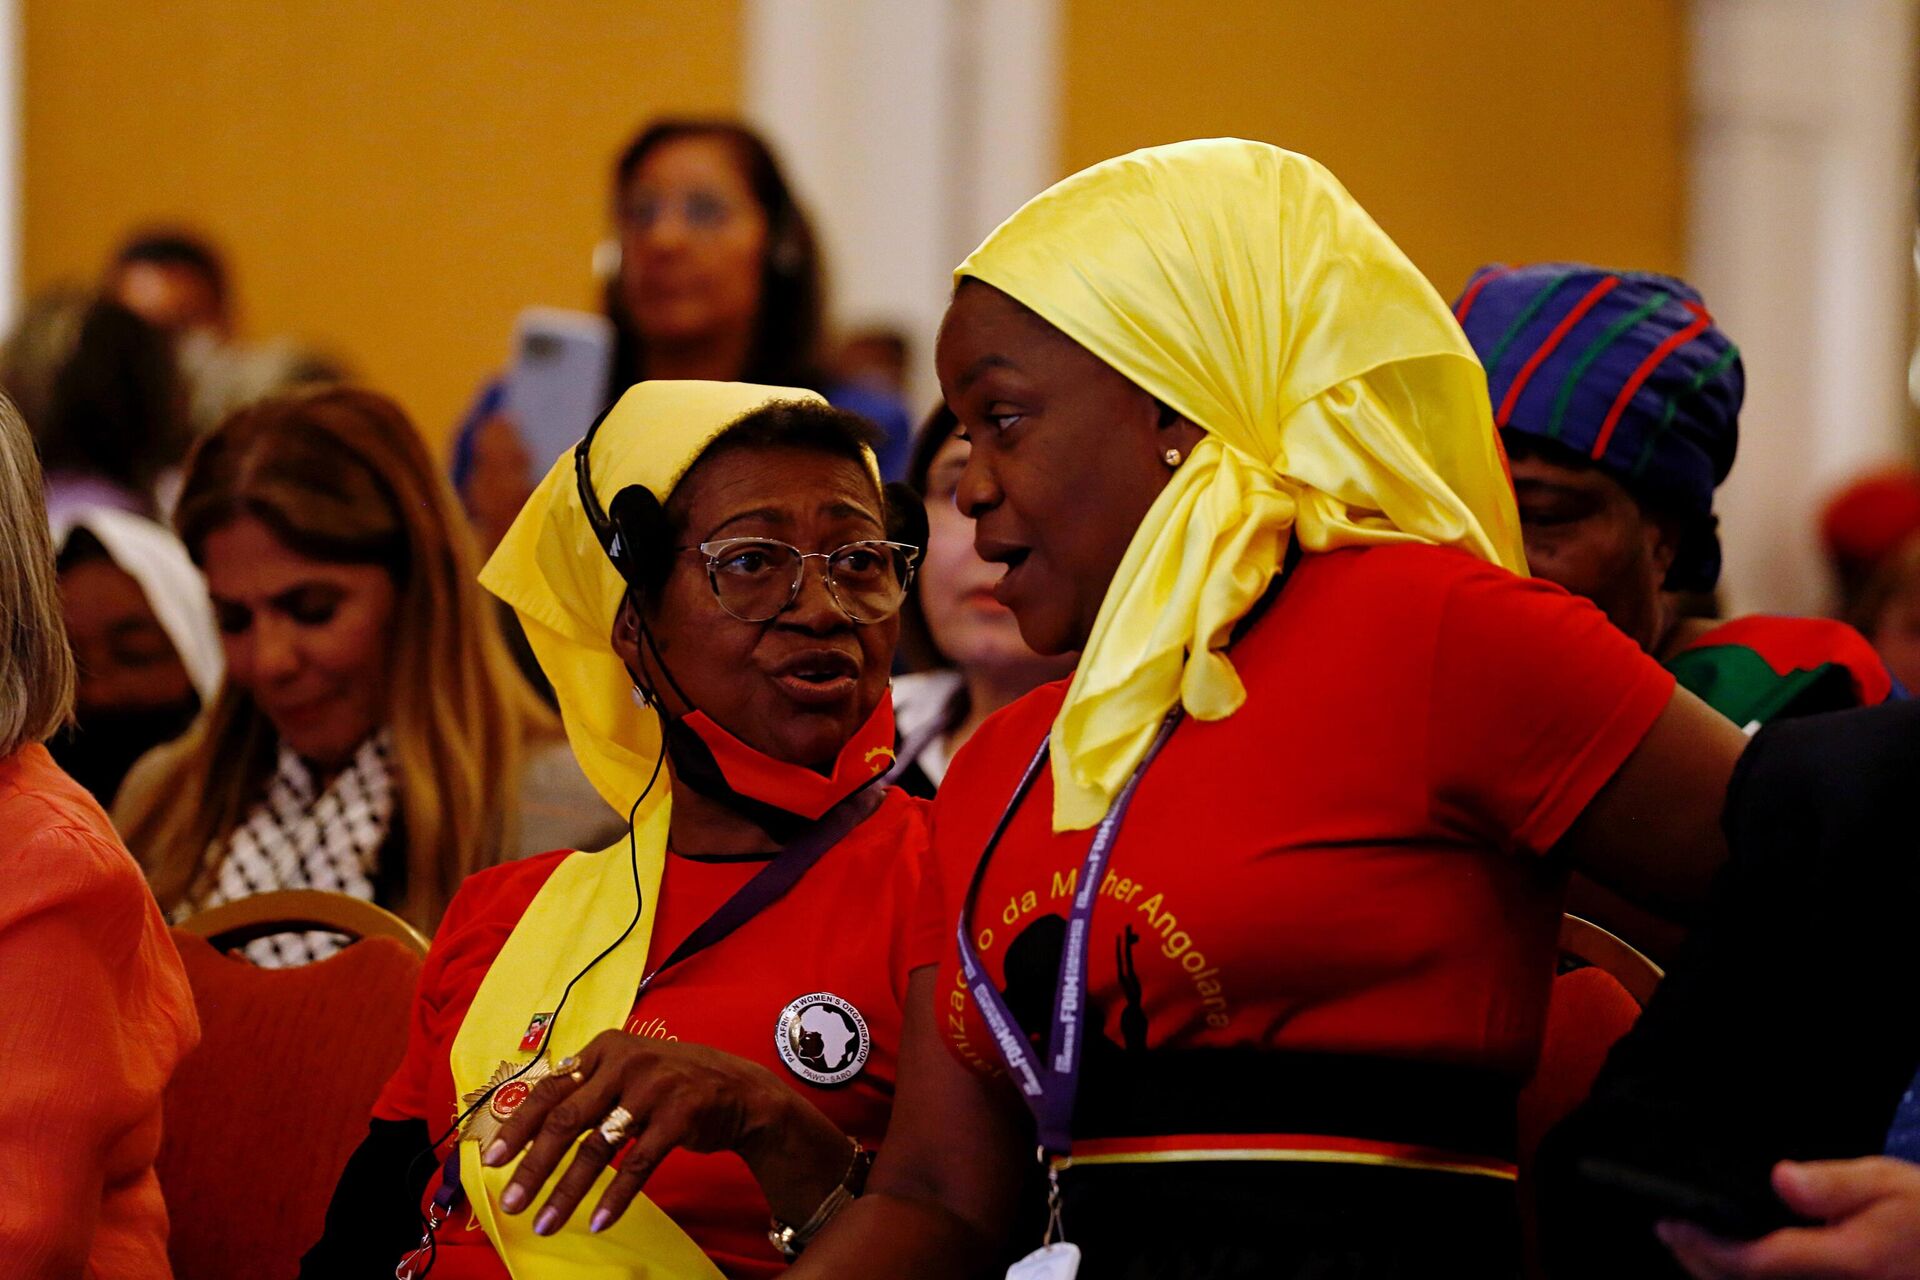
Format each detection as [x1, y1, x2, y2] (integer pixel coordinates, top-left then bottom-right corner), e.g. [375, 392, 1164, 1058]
[914, 545, 1674, 1138]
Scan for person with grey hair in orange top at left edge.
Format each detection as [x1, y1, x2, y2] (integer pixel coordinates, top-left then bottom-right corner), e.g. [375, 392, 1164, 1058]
[0, 387, 200, 1278]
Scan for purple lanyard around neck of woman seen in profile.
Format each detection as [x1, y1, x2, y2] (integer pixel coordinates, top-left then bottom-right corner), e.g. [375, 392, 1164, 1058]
[958, 706, 1181, 1155]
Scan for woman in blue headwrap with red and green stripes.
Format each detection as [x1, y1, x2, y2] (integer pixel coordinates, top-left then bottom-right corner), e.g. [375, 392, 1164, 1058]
[1453, 263, 1891, 733]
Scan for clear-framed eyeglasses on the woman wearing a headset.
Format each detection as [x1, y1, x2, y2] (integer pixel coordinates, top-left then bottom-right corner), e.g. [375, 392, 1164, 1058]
[680, 537, 920, 622]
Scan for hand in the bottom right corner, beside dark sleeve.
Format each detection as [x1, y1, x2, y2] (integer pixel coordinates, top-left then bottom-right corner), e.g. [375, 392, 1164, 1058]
[1659, 1155, 1920, 1280]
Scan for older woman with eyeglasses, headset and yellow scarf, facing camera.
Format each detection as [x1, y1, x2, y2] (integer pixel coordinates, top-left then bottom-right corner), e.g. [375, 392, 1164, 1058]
[305, 382, 927, 1276]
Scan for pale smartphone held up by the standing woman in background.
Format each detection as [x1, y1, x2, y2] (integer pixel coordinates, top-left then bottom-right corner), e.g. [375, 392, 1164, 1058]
[505, 307, 612, 478]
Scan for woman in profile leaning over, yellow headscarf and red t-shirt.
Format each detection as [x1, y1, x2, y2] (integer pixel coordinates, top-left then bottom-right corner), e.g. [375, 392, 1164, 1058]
[795, 140, 1741, 1278]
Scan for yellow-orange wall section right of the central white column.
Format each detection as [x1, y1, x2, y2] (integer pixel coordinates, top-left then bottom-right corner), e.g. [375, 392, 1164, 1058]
[1062, 0, 1686, 297]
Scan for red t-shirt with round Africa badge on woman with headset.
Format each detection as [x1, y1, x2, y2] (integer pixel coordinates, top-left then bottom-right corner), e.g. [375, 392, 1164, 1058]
[374, 791, 927, 1280]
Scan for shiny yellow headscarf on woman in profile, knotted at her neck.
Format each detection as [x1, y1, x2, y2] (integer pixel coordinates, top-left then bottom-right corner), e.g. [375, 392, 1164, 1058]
[954, 138, 1526, 831]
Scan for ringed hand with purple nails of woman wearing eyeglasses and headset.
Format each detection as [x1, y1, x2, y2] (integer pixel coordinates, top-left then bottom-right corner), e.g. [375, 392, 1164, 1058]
[480, 1031, 852, 1236]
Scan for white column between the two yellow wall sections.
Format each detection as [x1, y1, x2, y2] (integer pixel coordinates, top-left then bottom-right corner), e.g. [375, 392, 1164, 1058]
[743, 0, 1060, 405]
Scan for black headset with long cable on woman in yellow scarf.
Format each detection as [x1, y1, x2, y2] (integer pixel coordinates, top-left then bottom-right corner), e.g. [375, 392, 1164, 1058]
[403, 401, 927, 1280]
